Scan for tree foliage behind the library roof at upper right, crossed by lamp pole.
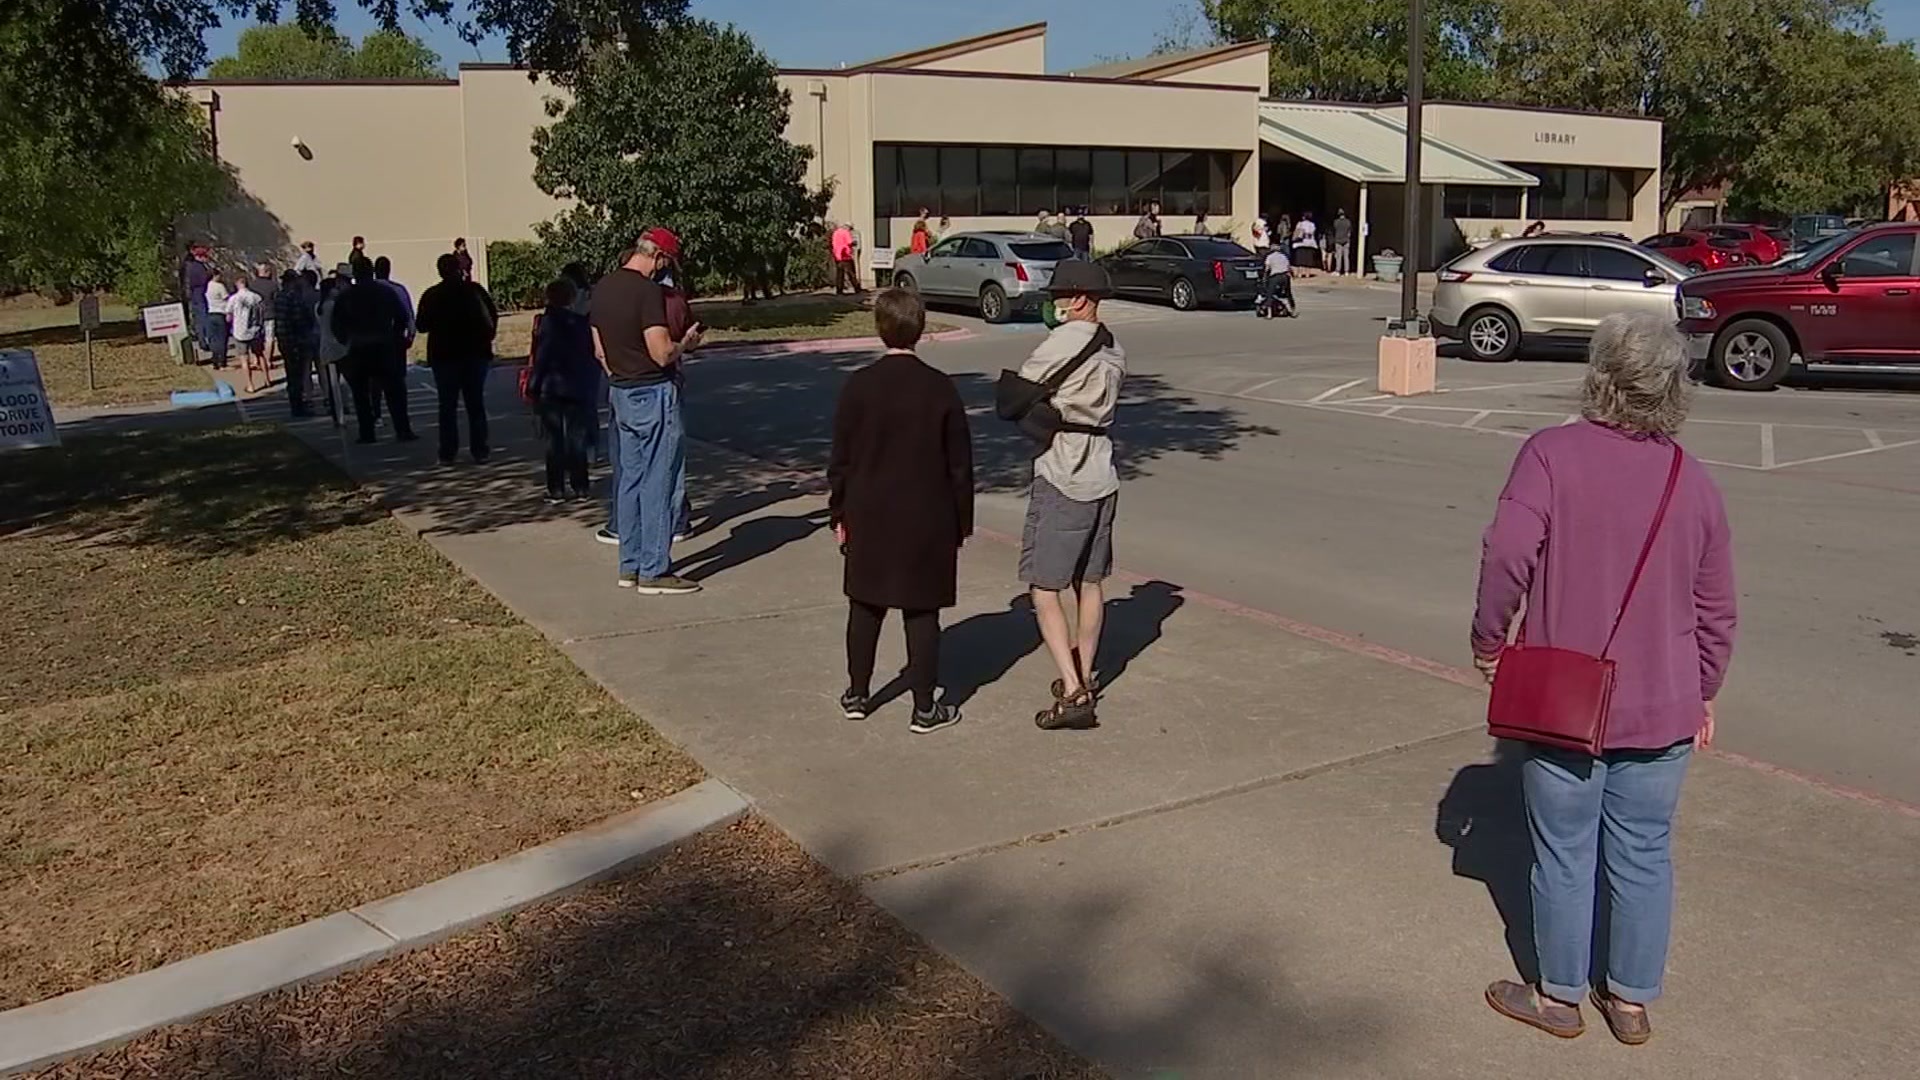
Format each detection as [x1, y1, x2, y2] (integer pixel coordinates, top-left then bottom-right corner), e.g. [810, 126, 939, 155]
[1204, 0, 1920, 215]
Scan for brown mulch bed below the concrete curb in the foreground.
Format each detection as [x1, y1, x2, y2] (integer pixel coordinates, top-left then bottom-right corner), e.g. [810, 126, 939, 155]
[38, 819, 1102, 1080]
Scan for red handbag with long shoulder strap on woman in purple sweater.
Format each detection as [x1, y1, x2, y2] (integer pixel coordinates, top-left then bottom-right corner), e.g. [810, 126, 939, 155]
[1486, 446, 1680, 757]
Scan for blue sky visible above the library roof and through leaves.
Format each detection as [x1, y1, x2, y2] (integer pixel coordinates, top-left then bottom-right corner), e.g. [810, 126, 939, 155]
[207, 0, 1920, 71]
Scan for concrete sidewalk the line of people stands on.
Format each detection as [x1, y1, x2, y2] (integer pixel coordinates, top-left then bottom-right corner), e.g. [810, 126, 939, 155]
[301, 380, 1920, 1080]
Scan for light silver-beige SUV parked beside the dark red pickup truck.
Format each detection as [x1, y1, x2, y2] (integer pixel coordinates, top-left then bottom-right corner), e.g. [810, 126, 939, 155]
[1430, 236, 1692, 359]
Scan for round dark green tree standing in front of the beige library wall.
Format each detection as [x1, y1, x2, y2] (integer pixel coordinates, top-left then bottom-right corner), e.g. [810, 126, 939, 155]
[534, 19, 828, 288]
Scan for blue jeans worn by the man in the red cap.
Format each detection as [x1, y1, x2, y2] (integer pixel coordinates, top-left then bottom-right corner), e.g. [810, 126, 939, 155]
[612, 382, 685, 580]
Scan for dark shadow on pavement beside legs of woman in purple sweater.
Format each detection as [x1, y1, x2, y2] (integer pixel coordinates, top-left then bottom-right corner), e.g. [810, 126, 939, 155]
[1434, 740, 1536, 982]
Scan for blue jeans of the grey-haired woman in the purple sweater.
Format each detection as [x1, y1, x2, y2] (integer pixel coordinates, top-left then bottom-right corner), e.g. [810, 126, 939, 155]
[1521, 742, 1693, 1005]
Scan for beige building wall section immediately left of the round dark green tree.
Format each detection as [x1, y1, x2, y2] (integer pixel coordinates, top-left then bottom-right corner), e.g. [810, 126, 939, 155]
[461, 67, 568, 248]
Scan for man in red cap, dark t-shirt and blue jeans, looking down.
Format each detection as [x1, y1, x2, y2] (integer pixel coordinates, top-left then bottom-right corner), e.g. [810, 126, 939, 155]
[589, 229, 703, 596]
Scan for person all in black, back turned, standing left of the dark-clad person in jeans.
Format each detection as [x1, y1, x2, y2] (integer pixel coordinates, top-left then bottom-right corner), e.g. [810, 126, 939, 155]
[414, 252, 499, 465]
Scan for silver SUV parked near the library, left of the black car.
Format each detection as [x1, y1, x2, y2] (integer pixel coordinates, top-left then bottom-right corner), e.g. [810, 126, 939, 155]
[893, 233, 1073, 323]
